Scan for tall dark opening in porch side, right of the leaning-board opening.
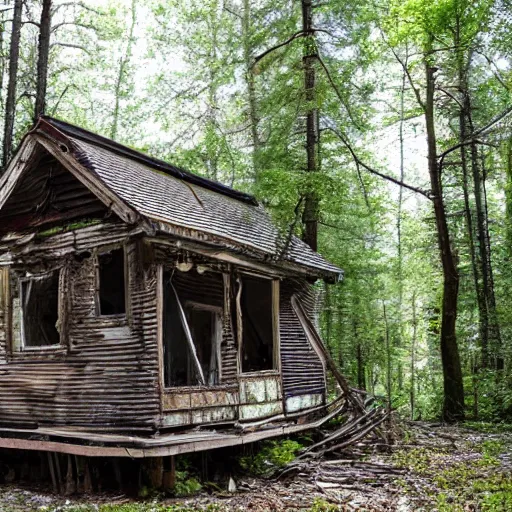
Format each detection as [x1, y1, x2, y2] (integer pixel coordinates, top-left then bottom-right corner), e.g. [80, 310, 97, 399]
[240, 275, 274, 372]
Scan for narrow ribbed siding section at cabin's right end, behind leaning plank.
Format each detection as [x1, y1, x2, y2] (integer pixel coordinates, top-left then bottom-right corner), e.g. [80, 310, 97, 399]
[279, 280, 325, 398]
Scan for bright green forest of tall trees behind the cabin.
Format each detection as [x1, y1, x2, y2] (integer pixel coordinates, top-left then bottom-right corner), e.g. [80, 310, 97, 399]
[0, 0, 512, 421]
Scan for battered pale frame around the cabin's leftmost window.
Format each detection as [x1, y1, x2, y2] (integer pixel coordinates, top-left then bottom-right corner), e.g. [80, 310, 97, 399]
[8, 267, 68, 354]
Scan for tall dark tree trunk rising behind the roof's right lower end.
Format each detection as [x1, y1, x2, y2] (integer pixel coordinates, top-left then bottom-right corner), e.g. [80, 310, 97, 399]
[302, 0, 319, 251]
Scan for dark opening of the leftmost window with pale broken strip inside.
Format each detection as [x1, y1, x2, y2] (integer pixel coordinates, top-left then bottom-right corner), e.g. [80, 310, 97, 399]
[20, 271, 60, 347]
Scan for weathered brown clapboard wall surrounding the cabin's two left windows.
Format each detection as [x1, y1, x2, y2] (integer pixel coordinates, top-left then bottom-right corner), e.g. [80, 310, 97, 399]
[0, 224, 160, 430]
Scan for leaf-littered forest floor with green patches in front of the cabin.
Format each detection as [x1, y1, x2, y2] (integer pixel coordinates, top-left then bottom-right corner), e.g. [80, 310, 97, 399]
[0, 423, 512, 512]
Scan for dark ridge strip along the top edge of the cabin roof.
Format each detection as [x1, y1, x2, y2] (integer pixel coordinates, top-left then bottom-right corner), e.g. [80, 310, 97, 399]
[36, 115, 259, 206]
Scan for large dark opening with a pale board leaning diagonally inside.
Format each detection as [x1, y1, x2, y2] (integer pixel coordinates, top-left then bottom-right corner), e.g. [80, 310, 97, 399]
[163, 271, 222, 387]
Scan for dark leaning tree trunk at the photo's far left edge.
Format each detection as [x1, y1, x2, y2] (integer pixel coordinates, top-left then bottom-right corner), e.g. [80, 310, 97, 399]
[2, 0, 23, 169]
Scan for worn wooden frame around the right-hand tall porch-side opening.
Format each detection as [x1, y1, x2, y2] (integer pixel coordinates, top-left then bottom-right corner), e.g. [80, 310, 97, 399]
[236, 270, 281, 378]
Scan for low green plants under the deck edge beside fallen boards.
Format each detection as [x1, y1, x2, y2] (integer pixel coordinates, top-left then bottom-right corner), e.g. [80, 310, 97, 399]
[239, 439, 303, 476]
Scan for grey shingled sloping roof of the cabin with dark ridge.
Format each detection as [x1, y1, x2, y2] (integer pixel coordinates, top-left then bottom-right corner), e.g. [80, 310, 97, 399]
[4, 116, 342, 279]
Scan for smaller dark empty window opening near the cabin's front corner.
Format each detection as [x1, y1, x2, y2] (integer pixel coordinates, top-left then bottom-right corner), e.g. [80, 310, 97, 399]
[98, 249, 126, 315]
